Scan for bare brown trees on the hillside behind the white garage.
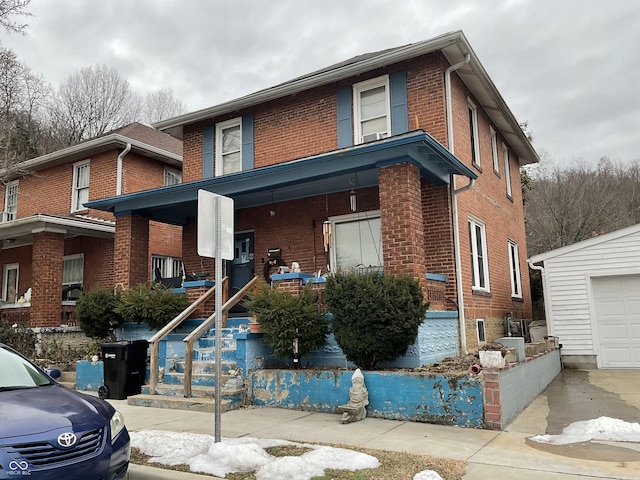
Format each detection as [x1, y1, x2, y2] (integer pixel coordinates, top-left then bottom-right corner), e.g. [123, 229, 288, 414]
[525, 157, 640, 255]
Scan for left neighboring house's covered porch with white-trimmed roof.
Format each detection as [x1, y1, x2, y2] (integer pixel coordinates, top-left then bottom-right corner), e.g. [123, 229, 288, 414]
[0, 214, 115, 327]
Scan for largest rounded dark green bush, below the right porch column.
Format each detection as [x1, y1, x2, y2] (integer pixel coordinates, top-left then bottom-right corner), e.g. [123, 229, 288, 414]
[325, 273, 429, 370]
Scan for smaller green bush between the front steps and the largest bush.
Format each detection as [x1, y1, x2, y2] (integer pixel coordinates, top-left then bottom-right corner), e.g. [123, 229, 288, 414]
[244, 284, 329, 359]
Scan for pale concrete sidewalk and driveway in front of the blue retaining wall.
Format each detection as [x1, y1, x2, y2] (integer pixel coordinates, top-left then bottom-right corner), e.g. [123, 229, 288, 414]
[110, 371, 640, 480]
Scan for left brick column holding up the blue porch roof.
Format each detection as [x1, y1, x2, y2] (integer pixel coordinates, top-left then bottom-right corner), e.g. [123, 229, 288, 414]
[113, 215, 150, 288]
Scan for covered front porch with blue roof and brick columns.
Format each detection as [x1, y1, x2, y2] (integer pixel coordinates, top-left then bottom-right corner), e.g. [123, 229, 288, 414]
[87, 130, 476, 309]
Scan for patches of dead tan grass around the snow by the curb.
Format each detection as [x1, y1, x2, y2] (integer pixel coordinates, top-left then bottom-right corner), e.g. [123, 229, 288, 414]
[131, 444, 467, 480]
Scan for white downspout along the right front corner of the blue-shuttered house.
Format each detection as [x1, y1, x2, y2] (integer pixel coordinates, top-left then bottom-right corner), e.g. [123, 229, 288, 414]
[444, 53, 475, 354]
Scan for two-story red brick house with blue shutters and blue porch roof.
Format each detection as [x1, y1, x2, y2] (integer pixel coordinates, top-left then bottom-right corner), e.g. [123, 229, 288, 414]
[90, 32, 538, 353]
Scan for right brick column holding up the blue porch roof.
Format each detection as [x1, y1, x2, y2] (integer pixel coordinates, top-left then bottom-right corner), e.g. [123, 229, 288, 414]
[378, 163, 426, 284]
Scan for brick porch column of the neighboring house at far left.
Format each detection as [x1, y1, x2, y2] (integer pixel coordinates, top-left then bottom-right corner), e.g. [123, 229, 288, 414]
[30, 228, 66, 327]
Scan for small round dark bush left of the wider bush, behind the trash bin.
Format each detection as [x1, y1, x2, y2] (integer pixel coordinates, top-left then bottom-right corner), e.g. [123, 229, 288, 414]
[76, 287, 122, 339]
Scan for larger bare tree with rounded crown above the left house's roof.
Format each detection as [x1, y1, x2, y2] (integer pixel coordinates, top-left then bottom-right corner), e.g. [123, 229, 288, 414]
[51, 65, 142, 146]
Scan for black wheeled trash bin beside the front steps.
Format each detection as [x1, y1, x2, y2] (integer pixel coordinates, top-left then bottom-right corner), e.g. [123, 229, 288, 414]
[98, 340, 149, 400]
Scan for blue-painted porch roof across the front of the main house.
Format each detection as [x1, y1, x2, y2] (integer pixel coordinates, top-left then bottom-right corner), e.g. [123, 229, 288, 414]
[85, 130, 477, 225]
